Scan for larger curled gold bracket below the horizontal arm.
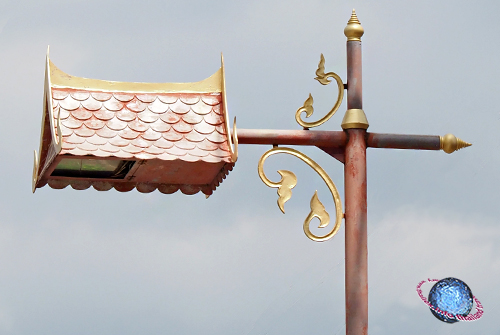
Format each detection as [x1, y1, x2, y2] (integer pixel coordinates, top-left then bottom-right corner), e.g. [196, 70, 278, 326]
[258, 147, 343, 242]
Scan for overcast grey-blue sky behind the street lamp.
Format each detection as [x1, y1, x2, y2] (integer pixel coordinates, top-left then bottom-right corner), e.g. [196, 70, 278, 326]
[0, 0, 500, 335]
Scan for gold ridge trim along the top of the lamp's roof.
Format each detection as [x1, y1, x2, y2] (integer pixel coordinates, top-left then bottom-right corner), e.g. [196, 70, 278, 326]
[47, 55, 223, 93]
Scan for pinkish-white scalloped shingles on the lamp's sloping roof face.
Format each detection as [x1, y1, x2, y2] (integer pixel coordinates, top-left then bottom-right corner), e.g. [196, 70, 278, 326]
[52, 88, 231, 163]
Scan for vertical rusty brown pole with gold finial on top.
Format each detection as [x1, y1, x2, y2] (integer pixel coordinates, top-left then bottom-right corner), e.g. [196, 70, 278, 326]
[342, 10, 368, 335]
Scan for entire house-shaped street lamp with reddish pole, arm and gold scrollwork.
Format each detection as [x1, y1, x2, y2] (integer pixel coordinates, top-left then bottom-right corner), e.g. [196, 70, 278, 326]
[33, 10, 471, 335]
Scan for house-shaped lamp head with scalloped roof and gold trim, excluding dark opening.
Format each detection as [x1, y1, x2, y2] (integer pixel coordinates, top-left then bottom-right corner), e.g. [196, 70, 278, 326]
[33, 51, 237, 195]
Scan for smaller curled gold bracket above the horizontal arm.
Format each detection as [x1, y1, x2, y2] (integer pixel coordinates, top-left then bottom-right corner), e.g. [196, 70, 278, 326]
[295, 54, 344, 128]
